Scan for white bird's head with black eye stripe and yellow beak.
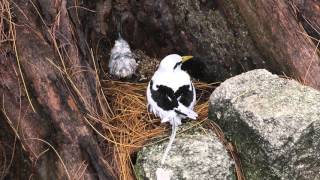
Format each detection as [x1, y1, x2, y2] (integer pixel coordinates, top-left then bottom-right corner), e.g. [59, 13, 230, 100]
[159, 54, 192, 71]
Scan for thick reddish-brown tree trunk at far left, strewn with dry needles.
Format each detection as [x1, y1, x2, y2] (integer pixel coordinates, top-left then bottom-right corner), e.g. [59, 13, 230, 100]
[0, 0, 112, 179]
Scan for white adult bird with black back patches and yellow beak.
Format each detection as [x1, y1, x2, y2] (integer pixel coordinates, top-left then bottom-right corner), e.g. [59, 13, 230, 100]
[147, 54, 198, 126]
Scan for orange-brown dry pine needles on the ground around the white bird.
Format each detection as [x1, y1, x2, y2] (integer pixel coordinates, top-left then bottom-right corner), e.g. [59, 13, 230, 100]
[85, 76, 242, 180]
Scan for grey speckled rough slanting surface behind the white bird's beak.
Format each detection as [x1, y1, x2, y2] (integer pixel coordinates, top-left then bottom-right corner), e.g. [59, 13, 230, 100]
[169, 0, 267, 82]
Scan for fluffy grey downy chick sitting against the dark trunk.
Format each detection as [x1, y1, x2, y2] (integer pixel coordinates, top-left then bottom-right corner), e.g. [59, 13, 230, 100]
[109, 34, 138, 78]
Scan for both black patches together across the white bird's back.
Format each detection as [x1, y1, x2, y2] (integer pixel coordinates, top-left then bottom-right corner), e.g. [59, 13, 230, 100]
[150, 80, 194, 111]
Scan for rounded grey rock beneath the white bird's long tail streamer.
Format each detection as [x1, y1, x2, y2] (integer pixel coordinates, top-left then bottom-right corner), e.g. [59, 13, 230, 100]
[135, 127, 235, 180]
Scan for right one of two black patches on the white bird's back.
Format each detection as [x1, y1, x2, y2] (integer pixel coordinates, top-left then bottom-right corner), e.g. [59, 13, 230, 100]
[174, 84, 194, 107]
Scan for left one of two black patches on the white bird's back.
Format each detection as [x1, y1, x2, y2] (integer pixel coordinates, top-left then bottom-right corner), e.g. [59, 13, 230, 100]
[150, 80, 179, 111]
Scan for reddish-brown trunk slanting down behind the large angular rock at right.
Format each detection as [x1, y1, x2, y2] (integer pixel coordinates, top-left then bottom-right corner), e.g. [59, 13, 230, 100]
[233, 0, 320, 89]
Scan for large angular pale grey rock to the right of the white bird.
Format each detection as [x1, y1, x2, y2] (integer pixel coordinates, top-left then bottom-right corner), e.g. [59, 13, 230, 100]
[209, 70, 320, 179]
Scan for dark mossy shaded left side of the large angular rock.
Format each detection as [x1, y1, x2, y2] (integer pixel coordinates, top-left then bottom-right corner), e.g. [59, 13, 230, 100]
[209, 106, 280, 180]
